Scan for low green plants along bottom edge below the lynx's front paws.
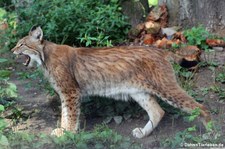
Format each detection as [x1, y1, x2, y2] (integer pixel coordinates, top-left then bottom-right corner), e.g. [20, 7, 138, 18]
[7, 126, 141, 149]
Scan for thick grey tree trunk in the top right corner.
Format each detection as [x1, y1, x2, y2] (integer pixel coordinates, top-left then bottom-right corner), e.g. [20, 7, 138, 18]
[159, 0, 225, 33]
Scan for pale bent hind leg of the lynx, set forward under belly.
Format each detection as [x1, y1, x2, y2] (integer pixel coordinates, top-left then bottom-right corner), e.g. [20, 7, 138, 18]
[131, 93, 165, 138]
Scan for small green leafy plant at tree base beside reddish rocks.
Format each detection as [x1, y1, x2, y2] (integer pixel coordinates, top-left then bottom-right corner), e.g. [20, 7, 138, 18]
[184, 26, 210, 50]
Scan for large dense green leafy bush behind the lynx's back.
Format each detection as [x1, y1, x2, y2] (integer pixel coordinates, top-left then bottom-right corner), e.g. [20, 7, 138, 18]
[5, 0, 129, 46]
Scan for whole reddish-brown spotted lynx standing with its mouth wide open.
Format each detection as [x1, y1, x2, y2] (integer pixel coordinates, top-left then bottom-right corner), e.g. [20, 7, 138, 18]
[12, 27, 210, 138]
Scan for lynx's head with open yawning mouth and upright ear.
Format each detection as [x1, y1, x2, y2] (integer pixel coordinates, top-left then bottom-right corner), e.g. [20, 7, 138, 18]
[12, 26, 44, 67]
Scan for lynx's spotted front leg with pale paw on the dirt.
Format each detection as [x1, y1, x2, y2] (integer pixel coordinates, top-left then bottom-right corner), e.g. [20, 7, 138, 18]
[52, 89, 80, 136]
